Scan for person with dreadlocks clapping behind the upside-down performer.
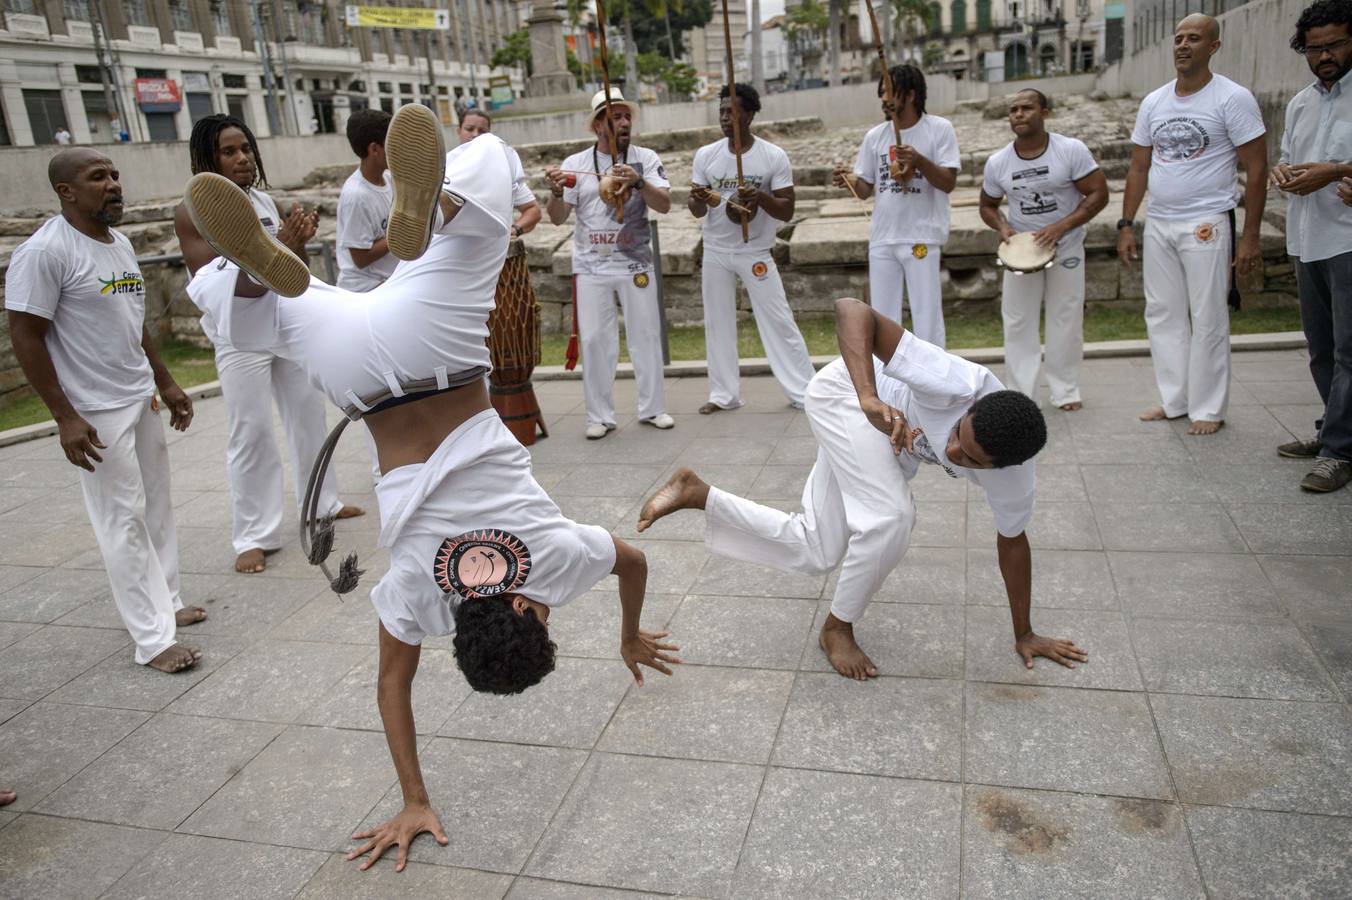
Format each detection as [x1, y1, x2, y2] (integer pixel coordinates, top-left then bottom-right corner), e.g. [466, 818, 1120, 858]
[173, 115, 362, 574]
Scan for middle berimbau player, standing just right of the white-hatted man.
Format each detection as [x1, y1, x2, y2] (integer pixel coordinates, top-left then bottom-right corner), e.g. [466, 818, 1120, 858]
[687, 84, 813, 415]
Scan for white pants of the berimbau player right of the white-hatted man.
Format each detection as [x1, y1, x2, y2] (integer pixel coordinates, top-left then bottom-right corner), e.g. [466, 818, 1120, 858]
[700, 246, 813, 409]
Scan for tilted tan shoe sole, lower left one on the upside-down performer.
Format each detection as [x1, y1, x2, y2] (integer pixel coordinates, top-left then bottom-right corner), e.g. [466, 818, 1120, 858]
[183, 172, 310, 297]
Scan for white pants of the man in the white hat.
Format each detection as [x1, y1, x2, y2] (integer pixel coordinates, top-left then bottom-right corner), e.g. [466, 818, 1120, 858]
[575, 272, 667, 424]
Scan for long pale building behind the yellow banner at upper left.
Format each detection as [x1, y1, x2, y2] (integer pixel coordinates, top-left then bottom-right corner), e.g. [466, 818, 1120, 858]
[0, 0, 530, 146]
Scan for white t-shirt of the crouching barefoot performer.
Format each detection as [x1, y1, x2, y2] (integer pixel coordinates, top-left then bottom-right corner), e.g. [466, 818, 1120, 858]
[876, 331, 1037, 538]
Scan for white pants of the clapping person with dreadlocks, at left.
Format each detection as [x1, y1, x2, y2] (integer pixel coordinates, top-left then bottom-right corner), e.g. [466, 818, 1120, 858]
[216, 347, 342, 553]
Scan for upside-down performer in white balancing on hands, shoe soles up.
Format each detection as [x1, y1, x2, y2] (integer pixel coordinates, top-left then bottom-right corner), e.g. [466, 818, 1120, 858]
[185, 105, 679, 869]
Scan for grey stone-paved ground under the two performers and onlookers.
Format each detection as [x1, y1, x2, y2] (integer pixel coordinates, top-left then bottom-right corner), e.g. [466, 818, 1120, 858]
[0, 362, 1352, 900]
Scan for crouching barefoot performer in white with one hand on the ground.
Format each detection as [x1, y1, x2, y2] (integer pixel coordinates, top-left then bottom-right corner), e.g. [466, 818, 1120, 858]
[638, 299, 1088, 680]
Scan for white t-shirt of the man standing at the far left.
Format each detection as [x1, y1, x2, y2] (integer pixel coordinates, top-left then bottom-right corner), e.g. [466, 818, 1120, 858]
[4, 215, 155, 411]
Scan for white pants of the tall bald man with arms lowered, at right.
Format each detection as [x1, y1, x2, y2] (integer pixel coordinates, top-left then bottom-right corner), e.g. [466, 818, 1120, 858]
[1144, 212, 1230, 422]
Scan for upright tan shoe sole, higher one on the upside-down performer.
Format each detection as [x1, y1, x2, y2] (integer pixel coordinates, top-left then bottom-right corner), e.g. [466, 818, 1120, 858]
[385, 104, 446, 259]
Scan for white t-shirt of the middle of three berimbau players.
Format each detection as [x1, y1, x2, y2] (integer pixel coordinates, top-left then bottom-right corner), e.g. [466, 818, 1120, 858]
[691, 138, 794, 254]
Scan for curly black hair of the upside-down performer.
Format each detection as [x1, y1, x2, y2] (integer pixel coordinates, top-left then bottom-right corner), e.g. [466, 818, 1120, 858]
[454, 593, 557, 693]
